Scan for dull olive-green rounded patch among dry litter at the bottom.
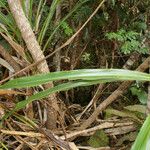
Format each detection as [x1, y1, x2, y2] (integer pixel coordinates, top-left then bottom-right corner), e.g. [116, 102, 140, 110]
[88, 130, 109, 148]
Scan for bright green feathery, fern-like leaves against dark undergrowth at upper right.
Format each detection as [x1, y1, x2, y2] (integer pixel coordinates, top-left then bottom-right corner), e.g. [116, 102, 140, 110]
[106, 29, 148, 54]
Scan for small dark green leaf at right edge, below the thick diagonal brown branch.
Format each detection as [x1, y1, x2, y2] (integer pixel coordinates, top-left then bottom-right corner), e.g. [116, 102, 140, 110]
[130, 86, 148, 104]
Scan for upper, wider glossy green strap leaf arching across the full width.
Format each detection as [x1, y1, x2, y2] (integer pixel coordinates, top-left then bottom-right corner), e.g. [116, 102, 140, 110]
[0, 69, 150, 89]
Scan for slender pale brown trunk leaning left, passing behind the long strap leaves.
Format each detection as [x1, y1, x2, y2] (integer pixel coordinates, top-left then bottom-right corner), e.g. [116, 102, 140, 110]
[7, 0, 58, 129]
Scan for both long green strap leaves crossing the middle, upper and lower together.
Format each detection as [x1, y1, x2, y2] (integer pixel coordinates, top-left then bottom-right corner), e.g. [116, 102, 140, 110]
[0, 69, 150, 119]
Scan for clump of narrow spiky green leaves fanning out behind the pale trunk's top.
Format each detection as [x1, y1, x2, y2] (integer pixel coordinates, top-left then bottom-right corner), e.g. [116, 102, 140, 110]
[0, 0, 89, 51]
